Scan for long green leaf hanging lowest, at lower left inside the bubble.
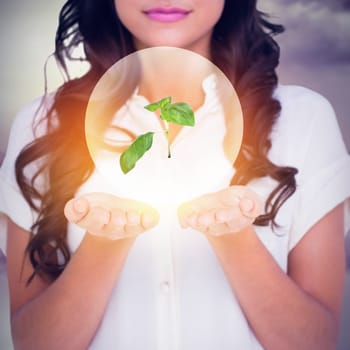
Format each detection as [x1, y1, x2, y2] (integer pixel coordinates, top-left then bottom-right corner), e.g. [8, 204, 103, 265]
[119, 132, 154, 174]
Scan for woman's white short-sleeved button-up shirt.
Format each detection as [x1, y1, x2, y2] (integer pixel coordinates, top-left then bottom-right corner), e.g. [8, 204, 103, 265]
[0, 80, 350, 350]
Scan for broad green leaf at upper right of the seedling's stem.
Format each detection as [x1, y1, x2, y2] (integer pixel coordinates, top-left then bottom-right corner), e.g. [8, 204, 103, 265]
[160, 102, 195, 126]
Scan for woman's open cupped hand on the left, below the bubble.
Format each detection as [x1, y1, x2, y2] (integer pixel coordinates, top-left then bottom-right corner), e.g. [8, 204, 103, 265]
[64, 192, 159, 240]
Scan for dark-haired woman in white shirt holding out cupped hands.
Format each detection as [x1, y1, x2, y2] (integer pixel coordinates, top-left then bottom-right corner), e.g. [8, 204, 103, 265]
[1, 0, 350, 349]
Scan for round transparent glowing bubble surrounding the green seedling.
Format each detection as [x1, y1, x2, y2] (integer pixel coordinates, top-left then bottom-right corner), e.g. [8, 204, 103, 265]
[85, 47, 243, 205]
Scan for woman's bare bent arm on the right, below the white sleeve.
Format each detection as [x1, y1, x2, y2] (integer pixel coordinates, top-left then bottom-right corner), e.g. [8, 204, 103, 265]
[182, 189, 345, 350]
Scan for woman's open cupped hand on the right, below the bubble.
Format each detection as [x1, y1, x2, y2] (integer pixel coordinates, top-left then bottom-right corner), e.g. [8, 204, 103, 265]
[178, 186, 262, 236]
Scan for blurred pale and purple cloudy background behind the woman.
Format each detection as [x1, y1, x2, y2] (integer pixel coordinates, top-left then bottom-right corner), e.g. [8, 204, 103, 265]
[0, 0, 350, 350]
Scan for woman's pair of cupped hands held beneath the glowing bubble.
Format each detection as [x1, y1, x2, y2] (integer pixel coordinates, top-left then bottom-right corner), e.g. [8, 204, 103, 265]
[64, 186, 262, 240]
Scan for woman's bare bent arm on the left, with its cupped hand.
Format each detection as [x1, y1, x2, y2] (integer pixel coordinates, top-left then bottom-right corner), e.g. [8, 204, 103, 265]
[7, 195, 157, 350]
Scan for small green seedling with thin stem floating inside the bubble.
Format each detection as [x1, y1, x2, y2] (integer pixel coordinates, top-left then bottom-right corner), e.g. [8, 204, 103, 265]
[120, 97, 195, 174]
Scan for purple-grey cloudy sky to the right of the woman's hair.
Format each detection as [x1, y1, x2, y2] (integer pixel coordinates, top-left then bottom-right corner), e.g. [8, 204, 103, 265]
[260, 0, 350, 149]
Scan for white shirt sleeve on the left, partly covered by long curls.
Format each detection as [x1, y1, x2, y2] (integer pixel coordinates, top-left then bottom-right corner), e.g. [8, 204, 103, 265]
[0, 99, 50, 253]
